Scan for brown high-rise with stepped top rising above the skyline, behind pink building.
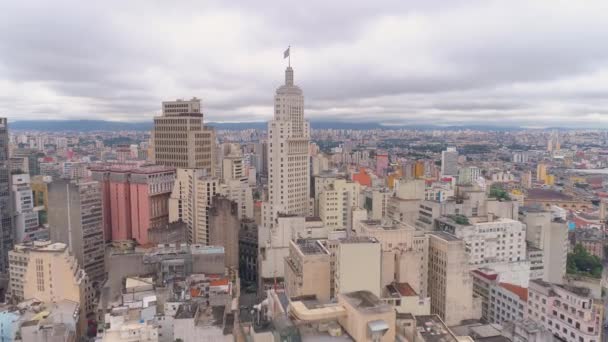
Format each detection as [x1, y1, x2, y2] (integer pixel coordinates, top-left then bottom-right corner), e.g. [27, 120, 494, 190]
[152, 98, 215, 176]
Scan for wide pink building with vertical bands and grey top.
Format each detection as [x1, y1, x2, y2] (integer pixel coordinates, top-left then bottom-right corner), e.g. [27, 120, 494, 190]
[91, 164, 175, 245]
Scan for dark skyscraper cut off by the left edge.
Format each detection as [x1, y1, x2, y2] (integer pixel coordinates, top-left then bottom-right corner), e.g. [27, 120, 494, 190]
[0, 118, 15, 273]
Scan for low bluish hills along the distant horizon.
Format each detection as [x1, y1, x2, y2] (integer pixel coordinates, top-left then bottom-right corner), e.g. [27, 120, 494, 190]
[9, 120, 520, 132]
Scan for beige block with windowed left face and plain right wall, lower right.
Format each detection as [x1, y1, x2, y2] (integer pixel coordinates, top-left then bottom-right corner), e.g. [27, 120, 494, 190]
[428, 232, 481, 326]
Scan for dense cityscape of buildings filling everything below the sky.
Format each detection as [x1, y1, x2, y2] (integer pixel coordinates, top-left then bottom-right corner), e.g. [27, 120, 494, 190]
[0, 61, 608, 342]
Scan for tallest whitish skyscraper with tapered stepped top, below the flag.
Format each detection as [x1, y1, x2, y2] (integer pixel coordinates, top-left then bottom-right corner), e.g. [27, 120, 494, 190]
[268, 66, 310, 220]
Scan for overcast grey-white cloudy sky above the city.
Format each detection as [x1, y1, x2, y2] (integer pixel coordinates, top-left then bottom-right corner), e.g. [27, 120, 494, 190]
[0, 0, 608, 128]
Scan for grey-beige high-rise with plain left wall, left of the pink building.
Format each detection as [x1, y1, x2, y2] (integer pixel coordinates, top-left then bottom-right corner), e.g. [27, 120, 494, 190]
[48, 180, 105, 286]
